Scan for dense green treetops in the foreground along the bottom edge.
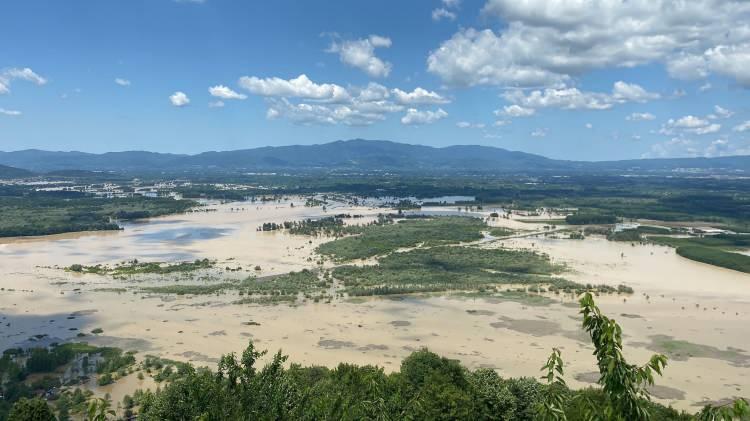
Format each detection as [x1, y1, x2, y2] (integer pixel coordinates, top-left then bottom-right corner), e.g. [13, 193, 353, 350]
[132, 344, 690, 421]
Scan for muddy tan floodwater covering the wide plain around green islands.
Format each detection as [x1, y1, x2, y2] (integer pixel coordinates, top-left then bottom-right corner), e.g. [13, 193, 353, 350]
[0, 198, 750, 412]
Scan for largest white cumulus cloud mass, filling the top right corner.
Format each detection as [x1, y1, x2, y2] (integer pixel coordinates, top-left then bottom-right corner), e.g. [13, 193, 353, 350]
[427, 0, 750, 87]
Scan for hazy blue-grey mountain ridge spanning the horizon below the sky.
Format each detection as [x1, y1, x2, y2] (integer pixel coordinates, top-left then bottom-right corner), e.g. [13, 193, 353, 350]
[0, 139, 750, 173]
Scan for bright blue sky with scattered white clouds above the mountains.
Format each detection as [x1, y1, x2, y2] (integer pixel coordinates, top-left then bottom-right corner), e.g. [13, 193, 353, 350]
[0, 0, 750, 160]
